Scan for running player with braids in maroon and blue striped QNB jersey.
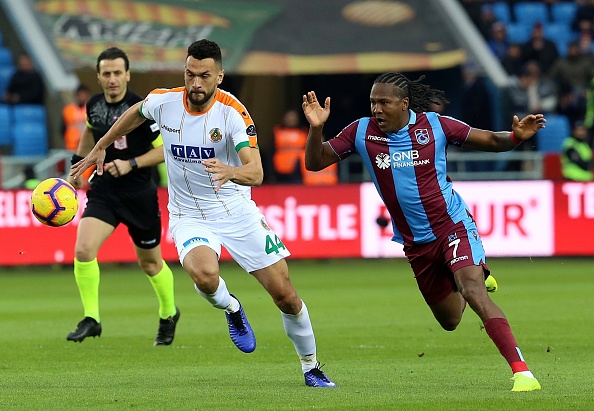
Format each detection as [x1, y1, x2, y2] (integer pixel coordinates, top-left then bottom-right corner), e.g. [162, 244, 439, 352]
[303, 73, 546, 391]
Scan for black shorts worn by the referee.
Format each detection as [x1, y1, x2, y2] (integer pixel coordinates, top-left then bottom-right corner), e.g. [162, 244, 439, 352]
[83, 184, 161, 249]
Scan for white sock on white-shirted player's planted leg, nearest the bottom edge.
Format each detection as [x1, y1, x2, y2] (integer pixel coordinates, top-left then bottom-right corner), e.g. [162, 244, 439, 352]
[281, 301, 318, 373]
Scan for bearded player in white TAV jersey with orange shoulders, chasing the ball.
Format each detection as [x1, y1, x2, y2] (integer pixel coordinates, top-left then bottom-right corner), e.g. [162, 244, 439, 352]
[71, 39, 336, 388]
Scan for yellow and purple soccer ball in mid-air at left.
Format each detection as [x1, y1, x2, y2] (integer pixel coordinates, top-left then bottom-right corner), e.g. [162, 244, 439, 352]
[31, 178, 78, 227]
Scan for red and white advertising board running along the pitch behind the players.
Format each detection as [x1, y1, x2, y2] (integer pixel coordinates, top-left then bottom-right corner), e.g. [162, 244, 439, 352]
[0, 181, 594, 266]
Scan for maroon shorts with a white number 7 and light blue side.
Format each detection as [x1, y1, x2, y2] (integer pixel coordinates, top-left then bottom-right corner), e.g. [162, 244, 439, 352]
[404, 219, 490, 305]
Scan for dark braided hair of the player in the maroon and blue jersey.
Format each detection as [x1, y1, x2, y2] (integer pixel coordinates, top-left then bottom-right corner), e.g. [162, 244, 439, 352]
[373, 72, 449, 113]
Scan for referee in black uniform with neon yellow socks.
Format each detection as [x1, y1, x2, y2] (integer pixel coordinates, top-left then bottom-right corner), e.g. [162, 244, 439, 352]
[66, 47, 180, 345]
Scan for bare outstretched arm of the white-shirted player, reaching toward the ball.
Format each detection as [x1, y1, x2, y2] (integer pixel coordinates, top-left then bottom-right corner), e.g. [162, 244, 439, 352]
[70, 102, 146, 179]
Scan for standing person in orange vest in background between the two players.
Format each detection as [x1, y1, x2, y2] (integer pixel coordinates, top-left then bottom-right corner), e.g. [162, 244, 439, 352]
[272, 109, 308, 184]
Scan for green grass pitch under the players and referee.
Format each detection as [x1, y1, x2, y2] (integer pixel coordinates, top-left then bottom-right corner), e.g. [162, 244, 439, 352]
[0, 258, 594, 411]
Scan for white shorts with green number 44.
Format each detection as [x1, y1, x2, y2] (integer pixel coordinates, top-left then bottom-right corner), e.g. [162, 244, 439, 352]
[170, 207, 291, 273]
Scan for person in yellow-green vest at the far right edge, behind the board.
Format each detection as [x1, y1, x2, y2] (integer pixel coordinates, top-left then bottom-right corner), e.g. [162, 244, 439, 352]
[561, 122, 594, 181]
